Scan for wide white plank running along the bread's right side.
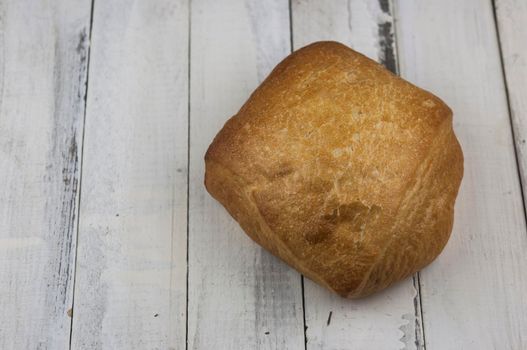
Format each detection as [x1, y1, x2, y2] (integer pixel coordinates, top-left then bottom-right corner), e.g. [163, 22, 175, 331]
[396, 0, 527, 349]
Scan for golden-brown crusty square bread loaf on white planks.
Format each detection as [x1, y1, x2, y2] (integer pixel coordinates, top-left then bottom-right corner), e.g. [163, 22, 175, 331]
[205, 42, 463, 298]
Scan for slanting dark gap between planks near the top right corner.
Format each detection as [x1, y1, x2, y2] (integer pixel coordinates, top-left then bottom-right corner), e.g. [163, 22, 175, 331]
[490, 0, 527, 224]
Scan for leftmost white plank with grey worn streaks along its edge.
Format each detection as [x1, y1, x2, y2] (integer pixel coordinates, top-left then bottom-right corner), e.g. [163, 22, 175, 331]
[0, 0, 90, 349]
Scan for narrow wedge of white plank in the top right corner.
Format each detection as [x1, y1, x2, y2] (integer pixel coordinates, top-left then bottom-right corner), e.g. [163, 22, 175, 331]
[495, 0, 527, 213]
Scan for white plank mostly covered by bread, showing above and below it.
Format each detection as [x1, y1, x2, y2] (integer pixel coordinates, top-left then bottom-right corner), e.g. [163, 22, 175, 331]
[292, 0, 423, 349]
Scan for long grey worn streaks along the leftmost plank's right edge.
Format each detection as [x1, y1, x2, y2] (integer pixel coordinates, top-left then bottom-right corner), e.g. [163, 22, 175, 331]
[44, 4, 93, 328]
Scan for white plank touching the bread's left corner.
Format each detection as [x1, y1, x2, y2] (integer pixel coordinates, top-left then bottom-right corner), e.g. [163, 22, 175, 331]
[188, 0, 304, 349]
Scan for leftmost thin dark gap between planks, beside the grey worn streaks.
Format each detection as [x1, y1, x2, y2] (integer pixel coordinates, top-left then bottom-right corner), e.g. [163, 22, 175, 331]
[69, 0, 95, 350]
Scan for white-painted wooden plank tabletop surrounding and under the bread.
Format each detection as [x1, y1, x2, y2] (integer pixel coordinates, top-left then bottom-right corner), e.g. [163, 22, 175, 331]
[0, 0, 527, 350]
